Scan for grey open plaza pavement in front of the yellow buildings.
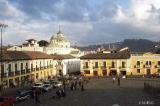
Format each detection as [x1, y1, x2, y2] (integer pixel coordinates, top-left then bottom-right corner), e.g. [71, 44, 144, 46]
[16, 78, 160, 106]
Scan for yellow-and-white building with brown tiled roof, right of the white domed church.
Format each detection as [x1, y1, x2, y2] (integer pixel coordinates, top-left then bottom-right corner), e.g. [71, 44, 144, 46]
[80, 51, 131, 76]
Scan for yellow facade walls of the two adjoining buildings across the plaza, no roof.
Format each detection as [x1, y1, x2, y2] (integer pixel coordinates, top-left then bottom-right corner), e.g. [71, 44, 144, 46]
[81, 53, 160, 76]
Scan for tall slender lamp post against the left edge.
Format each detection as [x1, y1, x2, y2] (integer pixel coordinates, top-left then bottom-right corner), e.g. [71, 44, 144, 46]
[0, 23, 8, 89]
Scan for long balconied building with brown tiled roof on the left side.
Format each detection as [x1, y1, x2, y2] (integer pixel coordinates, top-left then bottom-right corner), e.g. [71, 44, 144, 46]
[0, 51, 56, 87]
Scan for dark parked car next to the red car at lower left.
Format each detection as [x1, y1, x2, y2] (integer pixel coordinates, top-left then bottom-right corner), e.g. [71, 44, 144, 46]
[16, 90, 33, 102]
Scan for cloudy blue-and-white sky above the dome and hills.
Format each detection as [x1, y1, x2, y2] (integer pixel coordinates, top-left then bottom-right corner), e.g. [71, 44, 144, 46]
[0, 0, 160, 45]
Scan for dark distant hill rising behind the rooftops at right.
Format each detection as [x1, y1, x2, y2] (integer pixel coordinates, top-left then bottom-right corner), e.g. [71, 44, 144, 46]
[77, 39, 157, 52]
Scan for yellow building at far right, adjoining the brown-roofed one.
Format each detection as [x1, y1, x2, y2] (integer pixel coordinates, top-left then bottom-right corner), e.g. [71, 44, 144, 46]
[130, 53, 160, 75]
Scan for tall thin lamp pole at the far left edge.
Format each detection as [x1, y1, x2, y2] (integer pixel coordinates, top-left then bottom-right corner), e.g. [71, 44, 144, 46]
[0, 23, 8, 90]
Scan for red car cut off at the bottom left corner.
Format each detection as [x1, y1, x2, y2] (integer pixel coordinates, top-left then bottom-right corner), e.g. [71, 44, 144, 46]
[0, 97, 16, 106]
